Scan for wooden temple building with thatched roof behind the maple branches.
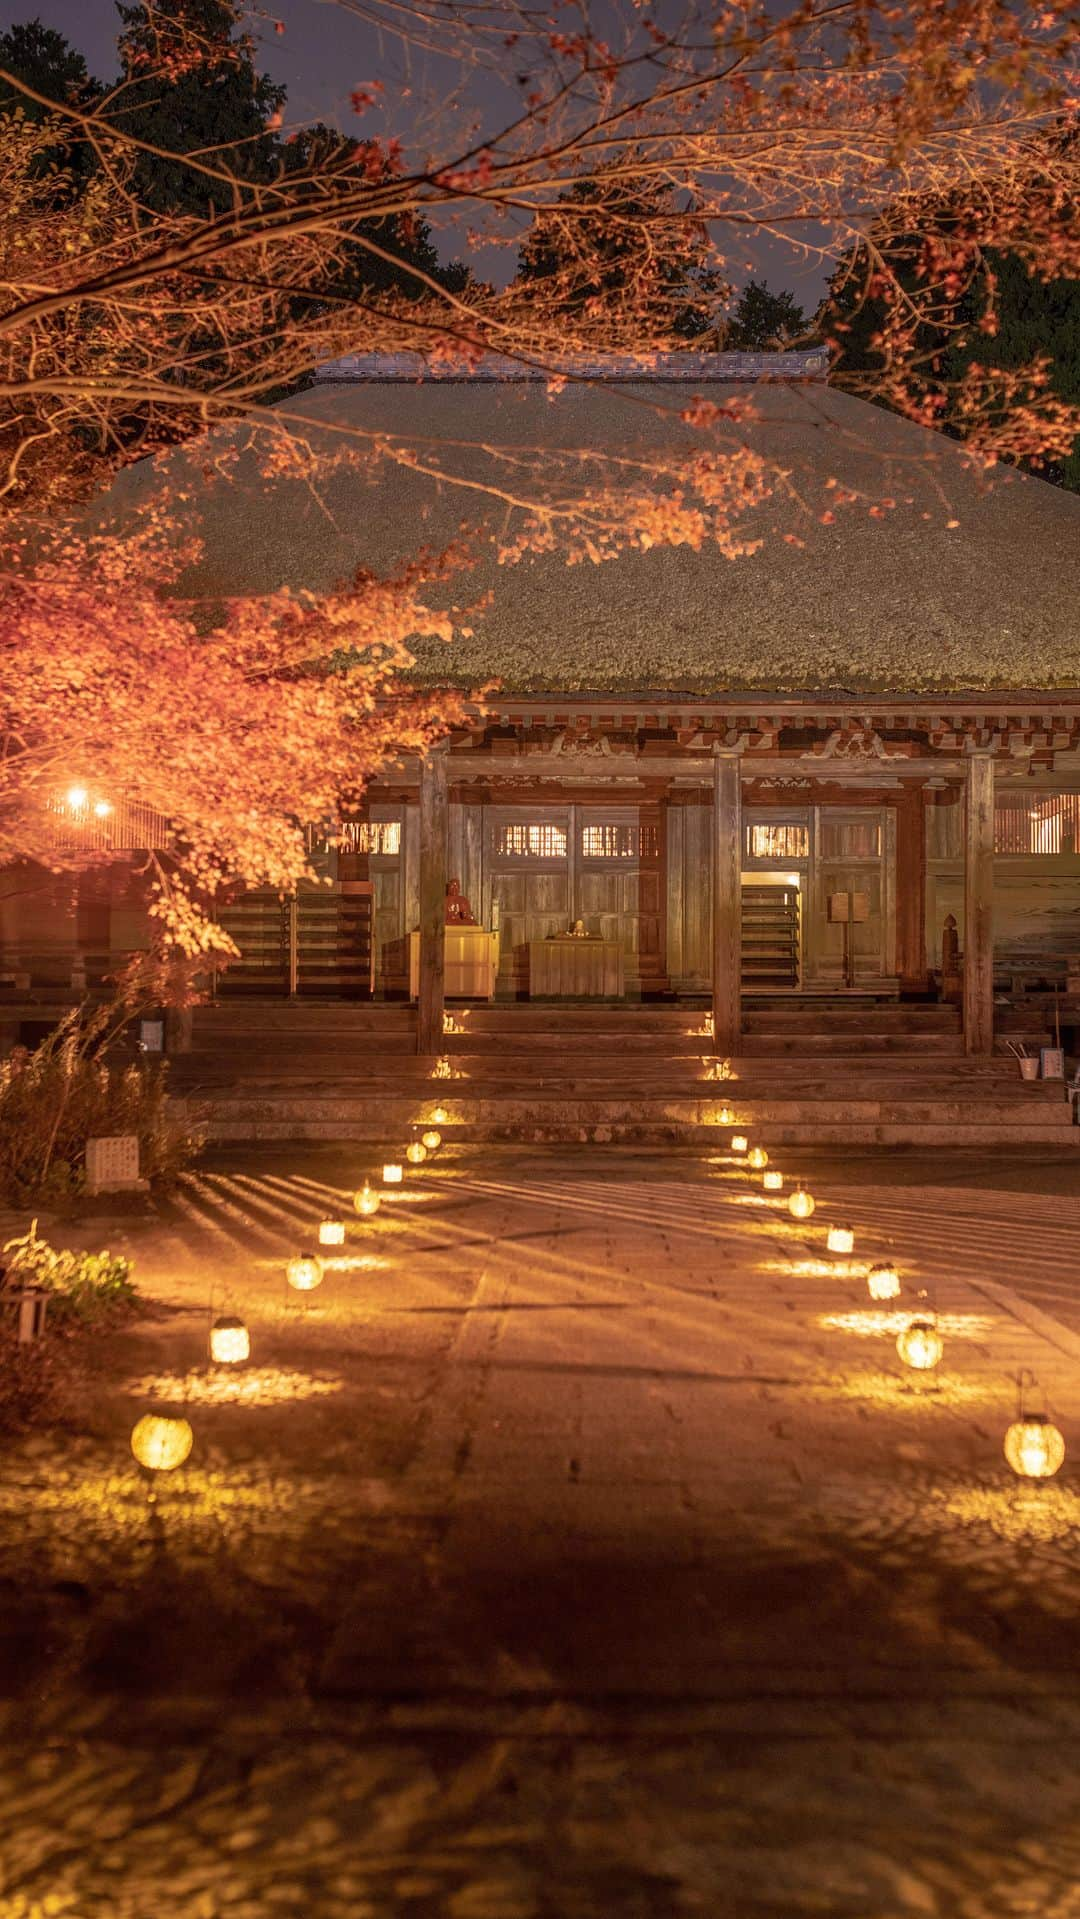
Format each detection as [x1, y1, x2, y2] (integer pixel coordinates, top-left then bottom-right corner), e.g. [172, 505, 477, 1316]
[0, 355, 1080, 1097]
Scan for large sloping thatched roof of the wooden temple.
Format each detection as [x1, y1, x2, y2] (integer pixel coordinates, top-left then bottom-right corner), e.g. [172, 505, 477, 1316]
[97, 362, 1080, 695]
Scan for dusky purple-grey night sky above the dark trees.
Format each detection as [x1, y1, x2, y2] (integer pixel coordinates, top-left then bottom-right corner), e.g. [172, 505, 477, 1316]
[0, 0, 827, 297]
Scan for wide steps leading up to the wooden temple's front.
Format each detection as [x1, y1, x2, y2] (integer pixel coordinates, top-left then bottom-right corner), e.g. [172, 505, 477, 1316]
[171, 1000, 1080, 1149]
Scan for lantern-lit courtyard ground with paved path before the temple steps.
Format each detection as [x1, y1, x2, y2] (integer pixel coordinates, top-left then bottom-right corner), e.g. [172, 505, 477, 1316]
[0, 1148, 1080, 1919]
